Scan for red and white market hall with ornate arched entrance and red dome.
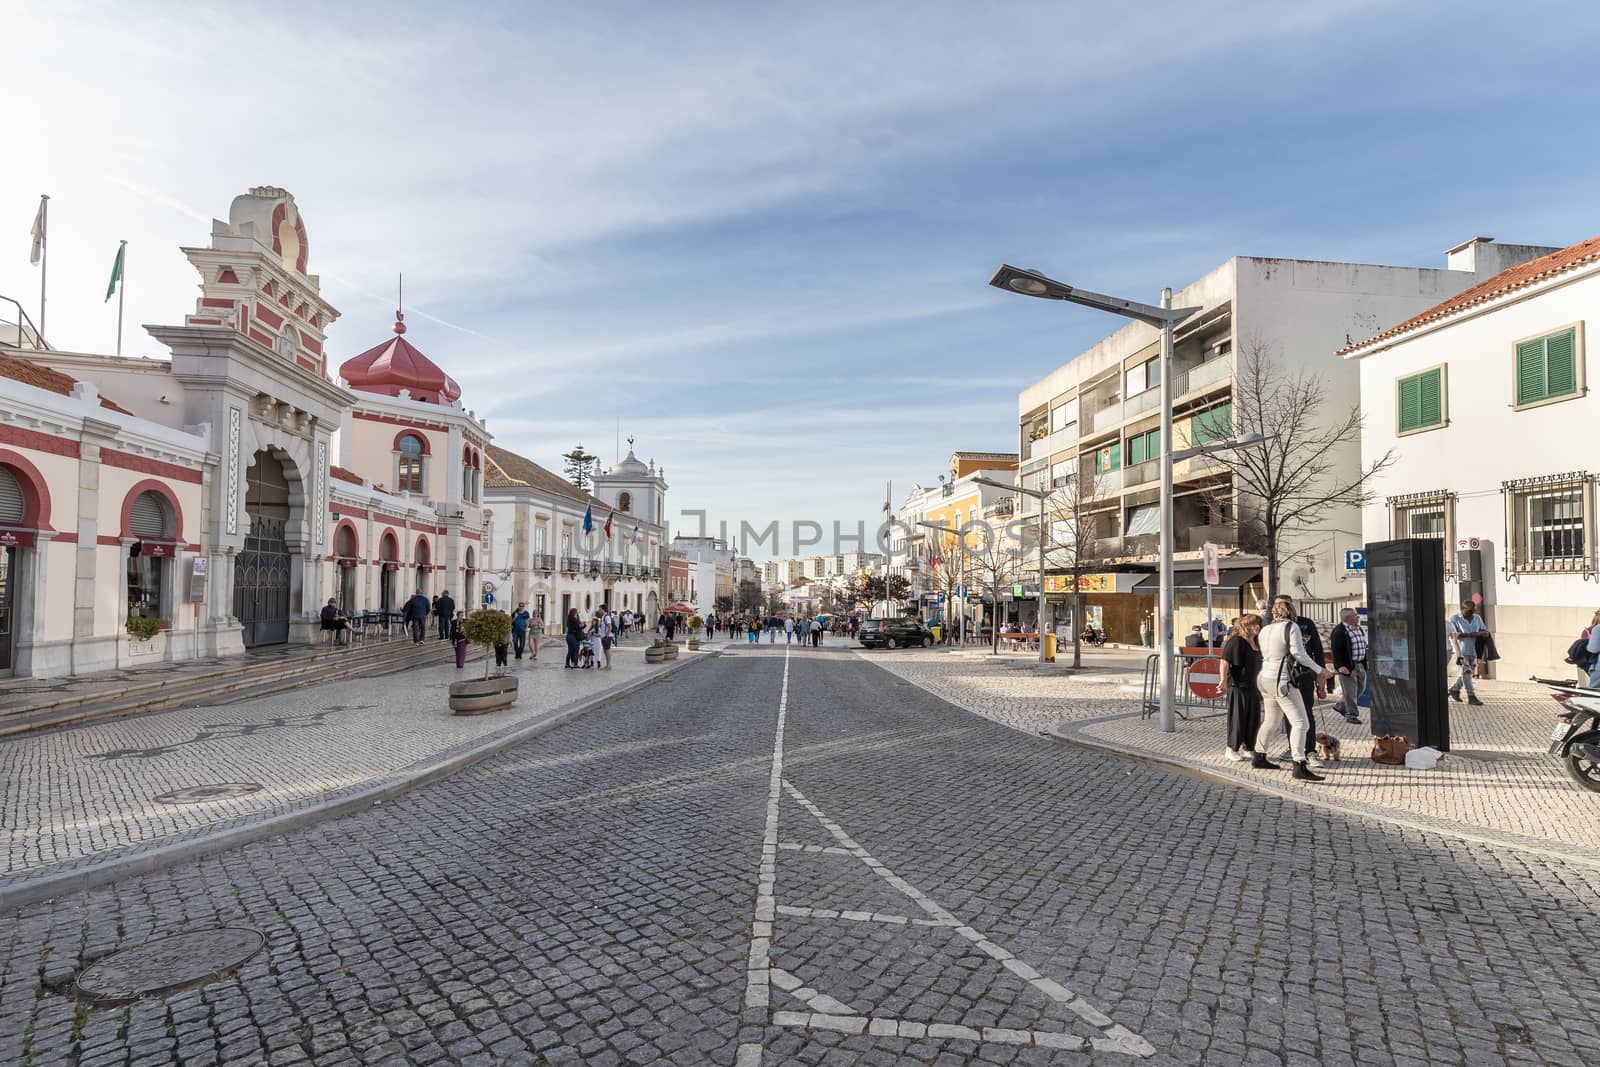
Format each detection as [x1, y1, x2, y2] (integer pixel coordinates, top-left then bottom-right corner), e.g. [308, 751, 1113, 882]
[0, 187, 490, 677]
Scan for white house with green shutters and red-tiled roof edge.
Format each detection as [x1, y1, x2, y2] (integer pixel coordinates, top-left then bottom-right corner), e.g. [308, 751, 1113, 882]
[1341, 237, 1600, 678]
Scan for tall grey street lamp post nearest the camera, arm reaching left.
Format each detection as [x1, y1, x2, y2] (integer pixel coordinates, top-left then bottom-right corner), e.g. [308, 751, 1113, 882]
[989, 264, 1200, 733]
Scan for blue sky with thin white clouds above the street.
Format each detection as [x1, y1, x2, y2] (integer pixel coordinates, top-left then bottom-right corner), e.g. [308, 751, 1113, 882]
[0, 0, 1600, 559]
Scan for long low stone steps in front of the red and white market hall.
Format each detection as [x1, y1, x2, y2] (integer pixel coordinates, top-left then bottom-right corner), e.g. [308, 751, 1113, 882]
[0, 637, 453, 736]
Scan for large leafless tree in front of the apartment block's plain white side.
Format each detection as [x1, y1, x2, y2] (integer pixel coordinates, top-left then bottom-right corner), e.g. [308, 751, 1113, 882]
[1195, 338, 1395, 595]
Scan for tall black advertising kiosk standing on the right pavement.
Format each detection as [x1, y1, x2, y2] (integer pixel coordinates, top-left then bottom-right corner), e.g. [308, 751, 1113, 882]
[1366, 537, 1450, 752]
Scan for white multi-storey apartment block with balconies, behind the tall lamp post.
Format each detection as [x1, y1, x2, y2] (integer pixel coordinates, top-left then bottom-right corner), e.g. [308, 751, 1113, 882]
[1014, 238, 1552, 641]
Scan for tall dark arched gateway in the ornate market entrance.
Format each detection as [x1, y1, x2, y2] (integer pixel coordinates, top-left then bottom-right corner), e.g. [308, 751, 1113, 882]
[234, 450, 290, 648]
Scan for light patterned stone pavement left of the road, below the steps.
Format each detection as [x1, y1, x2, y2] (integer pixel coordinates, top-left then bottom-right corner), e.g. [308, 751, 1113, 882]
[0, 638, 693, 893]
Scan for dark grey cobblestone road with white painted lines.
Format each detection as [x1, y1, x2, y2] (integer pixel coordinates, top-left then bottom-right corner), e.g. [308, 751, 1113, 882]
[0, 645, 1600, 1067]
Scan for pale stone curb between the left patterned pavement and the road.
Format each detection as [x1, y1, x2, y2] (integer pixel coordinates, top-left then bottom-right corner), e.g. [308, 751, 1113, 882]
[0, 649, 718, 912]
